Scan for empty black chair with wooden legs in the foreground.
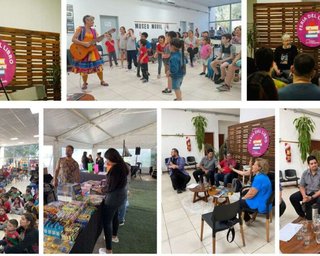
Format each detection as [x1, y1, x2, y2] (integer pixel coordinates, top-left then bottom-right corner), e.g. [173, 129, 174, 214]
[200, 201, 246, 253]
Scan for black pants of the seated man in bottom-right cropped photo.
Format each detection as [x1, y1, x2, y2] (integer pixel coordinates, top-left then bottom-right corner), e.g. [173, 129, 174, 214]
[290, 191, 320, 220]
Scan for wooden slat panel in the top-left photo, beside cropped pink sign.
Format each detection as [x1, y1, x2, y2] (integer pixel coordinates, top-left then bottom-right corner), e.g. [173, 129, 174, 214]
[0, 27, 61, 100]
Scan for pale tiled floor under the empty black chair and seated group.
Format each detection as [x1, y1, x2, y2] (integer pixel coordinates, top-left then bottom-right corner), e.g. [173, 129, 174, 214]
[161, 171, 275, 254]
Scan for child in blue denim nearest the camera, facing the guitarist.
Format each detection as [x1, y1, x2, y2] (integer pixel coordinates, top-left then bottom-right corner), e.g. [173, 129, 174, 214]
[168, 38, 186, 101]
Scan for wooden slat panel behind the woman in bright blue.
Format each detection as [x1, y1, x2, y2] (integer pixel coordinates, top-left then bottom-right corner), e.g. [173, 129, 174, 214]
[228, 117, 275, 171]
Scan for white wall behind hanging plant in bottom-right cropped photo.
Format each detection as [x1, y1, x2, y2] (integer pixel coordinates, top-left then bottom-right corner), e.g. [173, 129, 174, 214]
[279, 109, 320, 177]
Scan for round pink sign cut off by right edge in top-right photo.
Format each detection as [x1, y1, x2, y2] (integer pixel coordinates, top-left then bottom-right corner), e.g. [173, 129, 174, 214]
[297, 12, 320, 47]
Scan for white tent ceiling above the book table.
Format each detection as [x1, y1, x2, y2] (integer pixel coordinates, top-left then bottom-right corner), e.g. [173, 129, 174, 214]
[44, 109, 157, 148]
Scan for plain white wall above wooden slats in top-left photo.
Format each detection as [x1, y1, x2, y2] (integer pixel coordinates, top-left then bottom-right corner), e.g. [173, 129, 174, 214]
[0, 0, 61, 33]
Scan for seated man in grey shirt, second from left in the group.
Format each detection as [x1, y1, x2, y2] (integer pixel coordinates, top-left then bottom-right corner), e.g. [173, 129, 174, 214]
[192, 148, 217, 185]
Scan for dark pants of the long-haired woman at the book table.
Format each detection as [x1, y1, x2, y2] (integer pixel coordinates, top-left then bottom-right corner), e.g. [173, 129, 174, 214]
[102, 188, 127, 250]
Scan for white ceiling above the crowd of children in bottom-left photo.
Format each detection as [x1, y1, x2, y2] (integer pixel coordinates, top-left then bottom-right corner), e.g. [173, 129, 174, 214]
[0, 109, 39, 146]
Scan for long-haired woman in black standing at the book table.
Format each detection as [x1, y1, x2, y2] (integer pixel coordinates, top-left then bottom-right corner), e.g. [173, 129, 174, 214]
[99, 148, 129, 253]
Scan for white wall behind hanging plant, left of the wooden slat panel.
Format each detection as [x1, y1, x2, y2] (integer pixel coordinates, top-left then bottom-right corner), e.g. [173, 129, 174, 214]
[161, 109, 239, 170]
